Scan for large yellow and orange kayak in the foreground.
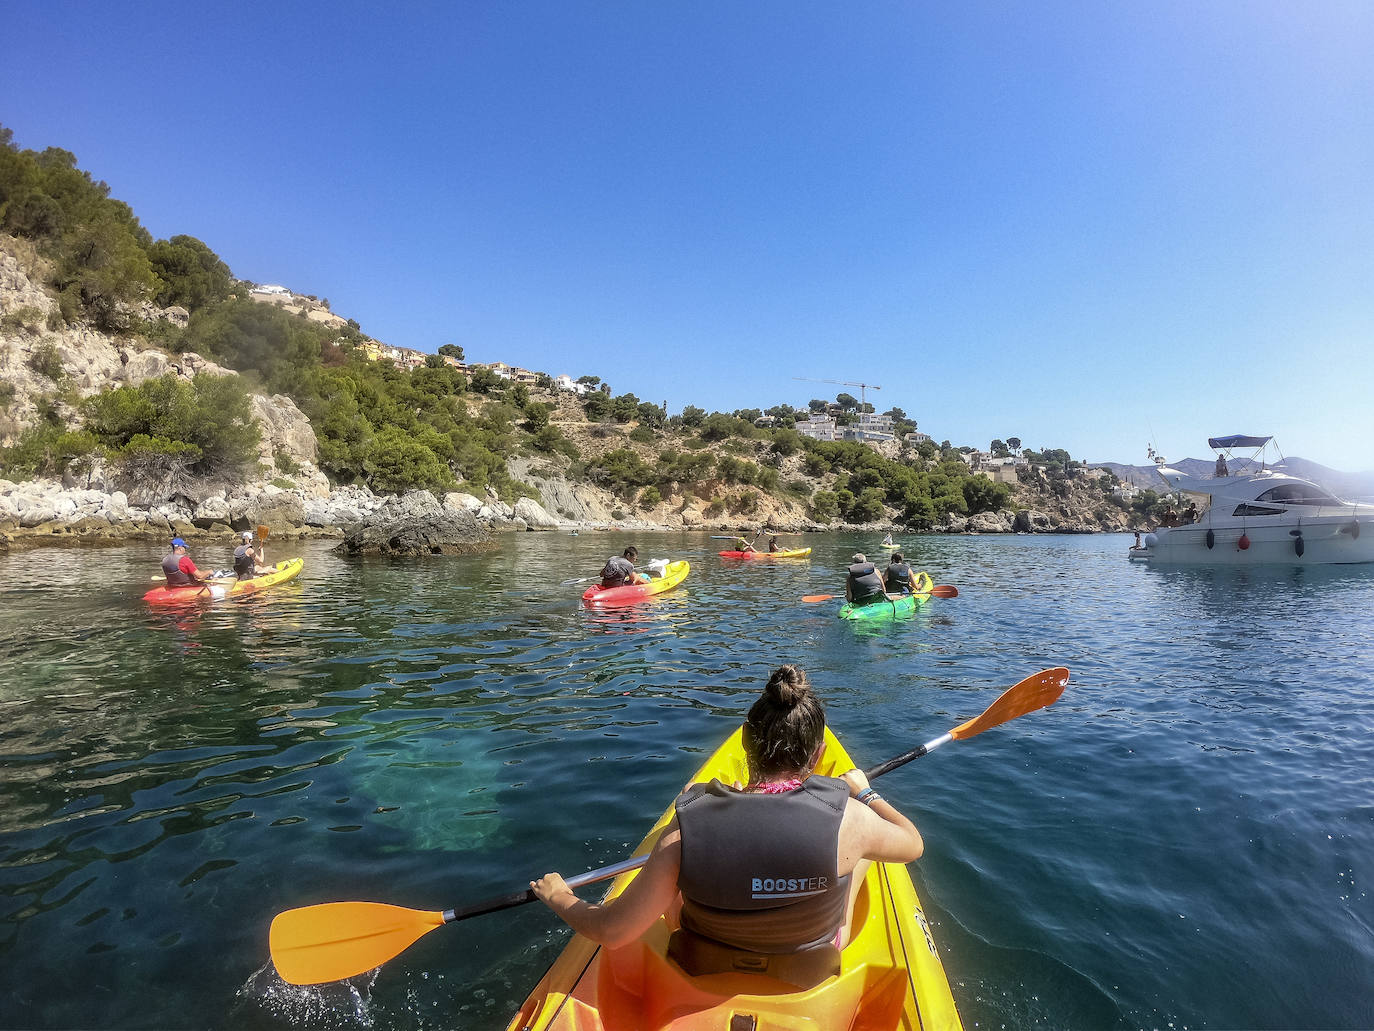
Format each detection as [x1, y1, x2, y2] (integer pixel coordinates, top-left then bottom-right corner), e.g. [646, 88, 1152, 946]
[508, 729, 962, 1031]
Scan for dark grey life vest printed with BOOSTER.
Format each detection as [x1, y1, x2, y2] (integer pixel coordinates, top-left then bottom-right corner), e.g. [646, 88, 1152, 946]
[675, 775, 849, 954]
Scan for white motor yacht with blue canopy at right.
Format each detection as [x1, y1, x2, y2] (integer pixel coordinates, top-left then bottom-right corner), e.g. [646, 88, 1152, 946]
[1145, 434, 1374, 565]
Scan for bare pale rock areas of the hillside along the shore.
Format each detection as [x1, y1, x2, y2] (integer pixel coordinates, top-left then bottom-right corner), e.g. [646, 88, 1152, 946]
[0, 226, 1127, 536]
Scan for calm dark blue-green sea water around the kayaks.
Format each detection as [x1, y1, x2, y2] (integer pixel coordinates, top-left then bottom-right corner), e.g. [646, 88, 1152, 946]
[0, 533, 1374, 1031]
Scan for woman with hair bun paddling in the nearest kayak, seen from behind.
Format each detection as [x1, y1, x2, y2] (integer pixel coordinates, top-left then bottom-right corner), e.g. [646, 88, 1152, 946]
[530, 665, 925, 979]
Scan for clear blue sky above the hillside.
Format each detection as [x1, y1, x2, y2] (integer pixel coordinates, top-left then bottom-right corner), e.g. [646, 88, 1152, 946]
[0, 0, 1374, 470]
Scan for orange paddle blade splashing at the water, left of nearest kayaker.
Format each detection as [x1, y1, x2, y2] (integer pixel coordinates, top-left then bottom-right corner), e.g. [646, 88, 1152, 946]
[268, 902, 444, 984]
